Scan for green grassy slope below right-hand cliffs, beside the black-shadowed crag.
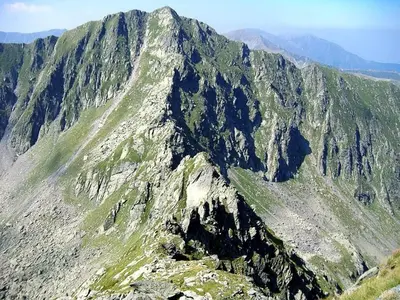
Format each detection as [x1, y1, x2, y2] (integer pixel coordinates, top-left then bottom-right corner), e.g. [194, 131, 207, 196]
[230, 148, 400, 289]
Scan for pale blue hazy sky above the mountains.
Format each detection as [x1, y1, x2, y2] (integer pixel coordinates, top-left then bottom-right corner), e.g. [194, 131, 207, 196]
[0, 0, 400, 62]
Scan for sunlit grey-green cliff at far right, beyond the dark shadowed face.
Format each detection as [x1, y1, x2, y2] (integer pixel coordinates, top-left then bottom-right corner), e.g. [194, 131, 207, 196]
[303, 66, 399, 212]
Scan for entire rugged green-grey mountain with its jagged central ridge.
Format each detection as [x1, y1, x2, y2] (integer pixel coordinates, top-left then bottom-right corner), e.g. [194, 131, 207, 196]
[0, 7, 400, 300]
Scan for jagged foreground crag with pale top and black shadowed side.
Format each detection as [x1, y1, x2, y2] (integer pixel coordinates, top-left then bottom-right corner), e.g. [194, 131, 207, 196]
[167, 165, 322, 299]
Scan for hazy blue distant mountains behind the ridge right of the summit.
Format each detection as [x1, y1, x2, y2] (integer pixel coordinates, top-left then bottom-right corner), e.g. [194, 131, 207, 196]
[226, 29, 400, 79]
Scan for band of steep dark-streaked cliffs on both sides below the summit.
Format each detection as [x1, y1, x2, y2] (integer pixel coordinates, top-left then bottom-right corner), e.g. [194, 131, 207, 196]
[0, 6, 400, 202]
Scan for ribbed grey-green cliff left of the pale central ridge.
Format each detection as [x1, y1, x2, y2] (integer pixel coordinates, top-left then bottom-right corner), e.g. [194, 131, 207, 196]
[4, 11, 145, 154]
